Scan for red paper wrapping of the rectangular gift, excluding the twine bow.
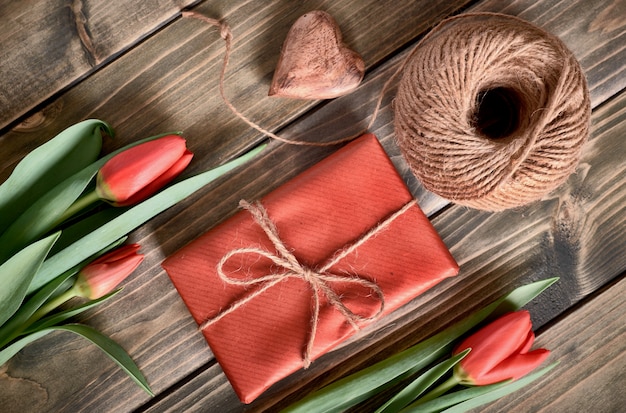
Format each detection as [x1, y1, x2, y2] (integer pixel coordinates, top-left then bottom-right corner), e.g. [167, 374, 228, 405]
[163, 134, 458, 403]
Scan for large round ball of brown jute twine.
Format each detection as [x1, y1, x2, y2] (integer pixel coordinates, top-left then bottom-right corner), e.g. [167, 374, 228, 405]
[394, 13, 590, 211]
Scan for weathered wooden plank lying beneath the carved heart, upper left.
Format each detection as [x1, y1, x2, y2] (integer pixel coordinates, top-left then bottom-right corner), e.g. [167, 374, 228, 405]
[0, 0, 468, 180]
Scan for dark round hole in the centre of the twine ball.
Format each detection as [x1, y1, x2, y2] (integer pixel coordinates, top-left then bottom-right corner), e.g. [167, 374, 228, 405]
[471, 87, 523, 140]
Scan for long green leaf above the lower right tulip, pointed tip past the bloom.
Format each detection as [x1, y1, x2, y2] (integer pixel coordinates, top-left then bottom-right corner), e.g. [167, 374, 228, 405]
[283, 278, 558, 413]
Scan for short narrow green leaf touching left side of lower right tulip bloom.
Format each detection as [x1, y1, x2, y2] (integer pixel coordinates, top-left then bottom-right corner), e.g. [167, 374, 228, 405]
[376, 349, 470, 413]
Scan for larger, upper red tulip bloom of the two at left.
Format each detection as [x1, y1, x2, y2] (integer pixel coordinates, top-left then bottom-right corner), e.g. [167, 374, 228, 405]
[96, 135, 193, 206]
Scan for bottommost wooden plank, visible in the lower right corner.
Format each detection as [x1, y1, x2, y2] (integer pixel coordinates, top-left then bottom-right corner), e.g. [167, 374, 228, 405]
[143, 278, 626, 413]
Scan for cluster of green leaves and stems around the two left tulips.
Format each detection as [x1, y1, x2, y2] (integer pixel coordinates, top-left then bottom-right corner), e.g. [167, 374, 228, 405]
[0, 119, 265, 395]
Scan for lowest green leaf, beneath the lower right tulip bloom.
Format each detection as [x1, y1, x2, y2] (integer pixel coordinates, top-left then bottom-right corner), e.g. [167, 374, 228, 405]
[402, 362, 559, 413]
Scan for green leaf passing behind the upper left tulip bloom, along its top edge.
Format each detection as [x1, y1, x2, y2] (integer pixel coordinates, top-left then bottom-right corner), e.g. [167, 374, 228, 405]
[0, 134, 171, 262]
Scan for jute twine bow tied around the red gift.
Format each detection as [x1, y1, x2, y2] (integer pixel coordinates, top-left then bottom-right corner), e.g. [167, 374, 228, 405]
[199, 200, 415, 368]
